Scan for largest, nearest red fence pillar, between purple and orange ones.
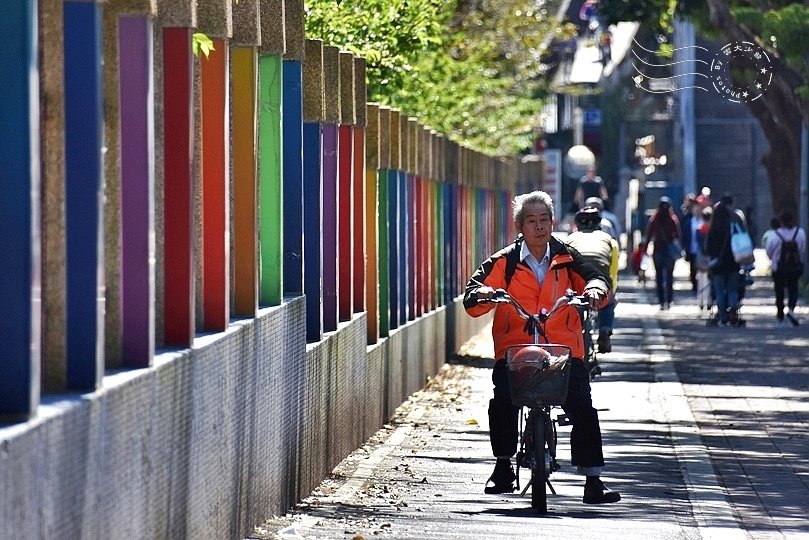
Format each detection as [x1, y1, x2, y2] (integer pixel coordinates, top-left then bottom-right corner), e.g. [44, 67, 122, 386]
[154, 0, 198, 347]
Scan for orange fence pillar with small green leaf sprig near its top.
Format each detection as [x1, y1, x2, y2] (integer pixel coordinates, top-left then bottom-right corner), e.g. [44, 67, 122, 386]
[197, 0, 233, 332]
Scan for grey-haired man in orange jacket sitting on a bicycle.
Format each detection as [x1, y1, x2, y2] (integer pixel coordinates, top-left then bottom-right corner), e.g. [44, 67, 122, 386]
[463, 191, 621, 504]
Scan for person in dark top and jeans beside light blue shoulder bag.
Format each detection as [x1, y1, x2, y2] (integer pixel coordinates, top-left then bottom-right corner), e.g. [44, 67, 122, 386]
[705, 194, 746, 325]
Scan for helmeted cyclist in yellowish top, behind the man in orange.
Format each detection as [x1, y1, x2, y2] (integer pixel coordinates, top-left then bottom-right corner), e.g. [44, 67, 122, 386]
[565, 206, 618, 353]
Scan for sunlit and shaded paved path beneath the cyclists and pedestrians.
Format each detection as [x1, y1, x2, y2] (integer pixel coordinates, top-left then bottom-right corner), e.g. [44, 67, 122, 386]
[251, 260, 809, 539]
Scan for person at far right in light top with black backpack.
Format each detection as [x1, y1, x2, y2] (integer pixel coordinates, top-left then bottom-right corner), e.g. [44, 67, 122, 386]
[765, 210, 806, 326]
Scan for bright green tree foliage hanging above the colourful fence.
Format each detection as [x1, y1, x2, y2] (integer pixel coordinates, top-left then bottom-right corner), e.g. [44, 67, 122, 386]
[306, 0, 561, 155]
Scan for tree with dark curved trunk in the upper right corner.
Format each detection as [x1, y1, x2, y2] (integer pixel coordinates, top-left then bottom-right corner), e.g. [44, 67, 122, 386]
[599, 0, 809, 215]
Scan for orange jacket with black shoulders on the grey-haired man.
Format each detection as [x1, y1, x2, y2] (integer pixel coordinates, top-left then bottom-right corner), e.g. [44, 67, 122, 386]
[464, 237, 610, 359]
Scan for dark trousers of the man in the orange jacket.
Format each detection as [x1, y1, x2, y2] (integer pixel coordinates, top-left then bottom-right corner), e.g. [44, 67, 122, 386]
[489, 360, 604, 467]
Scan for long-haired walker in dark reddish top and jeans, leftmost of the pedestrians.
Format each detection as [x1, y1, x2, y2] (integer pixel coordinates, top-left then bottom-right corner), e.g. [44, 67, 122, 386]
[642, 196, 682, 309]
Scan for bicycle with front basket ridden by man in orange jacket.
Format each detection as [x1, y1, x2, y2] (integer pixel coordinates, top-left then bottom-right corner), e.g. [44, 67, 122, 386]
[480, 289, 590, 514]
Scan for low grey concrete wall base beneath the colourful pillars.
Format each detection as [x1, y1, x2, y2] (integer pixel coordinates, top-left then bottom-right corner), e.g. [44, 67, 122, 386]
[0, 297, 487, 540]
